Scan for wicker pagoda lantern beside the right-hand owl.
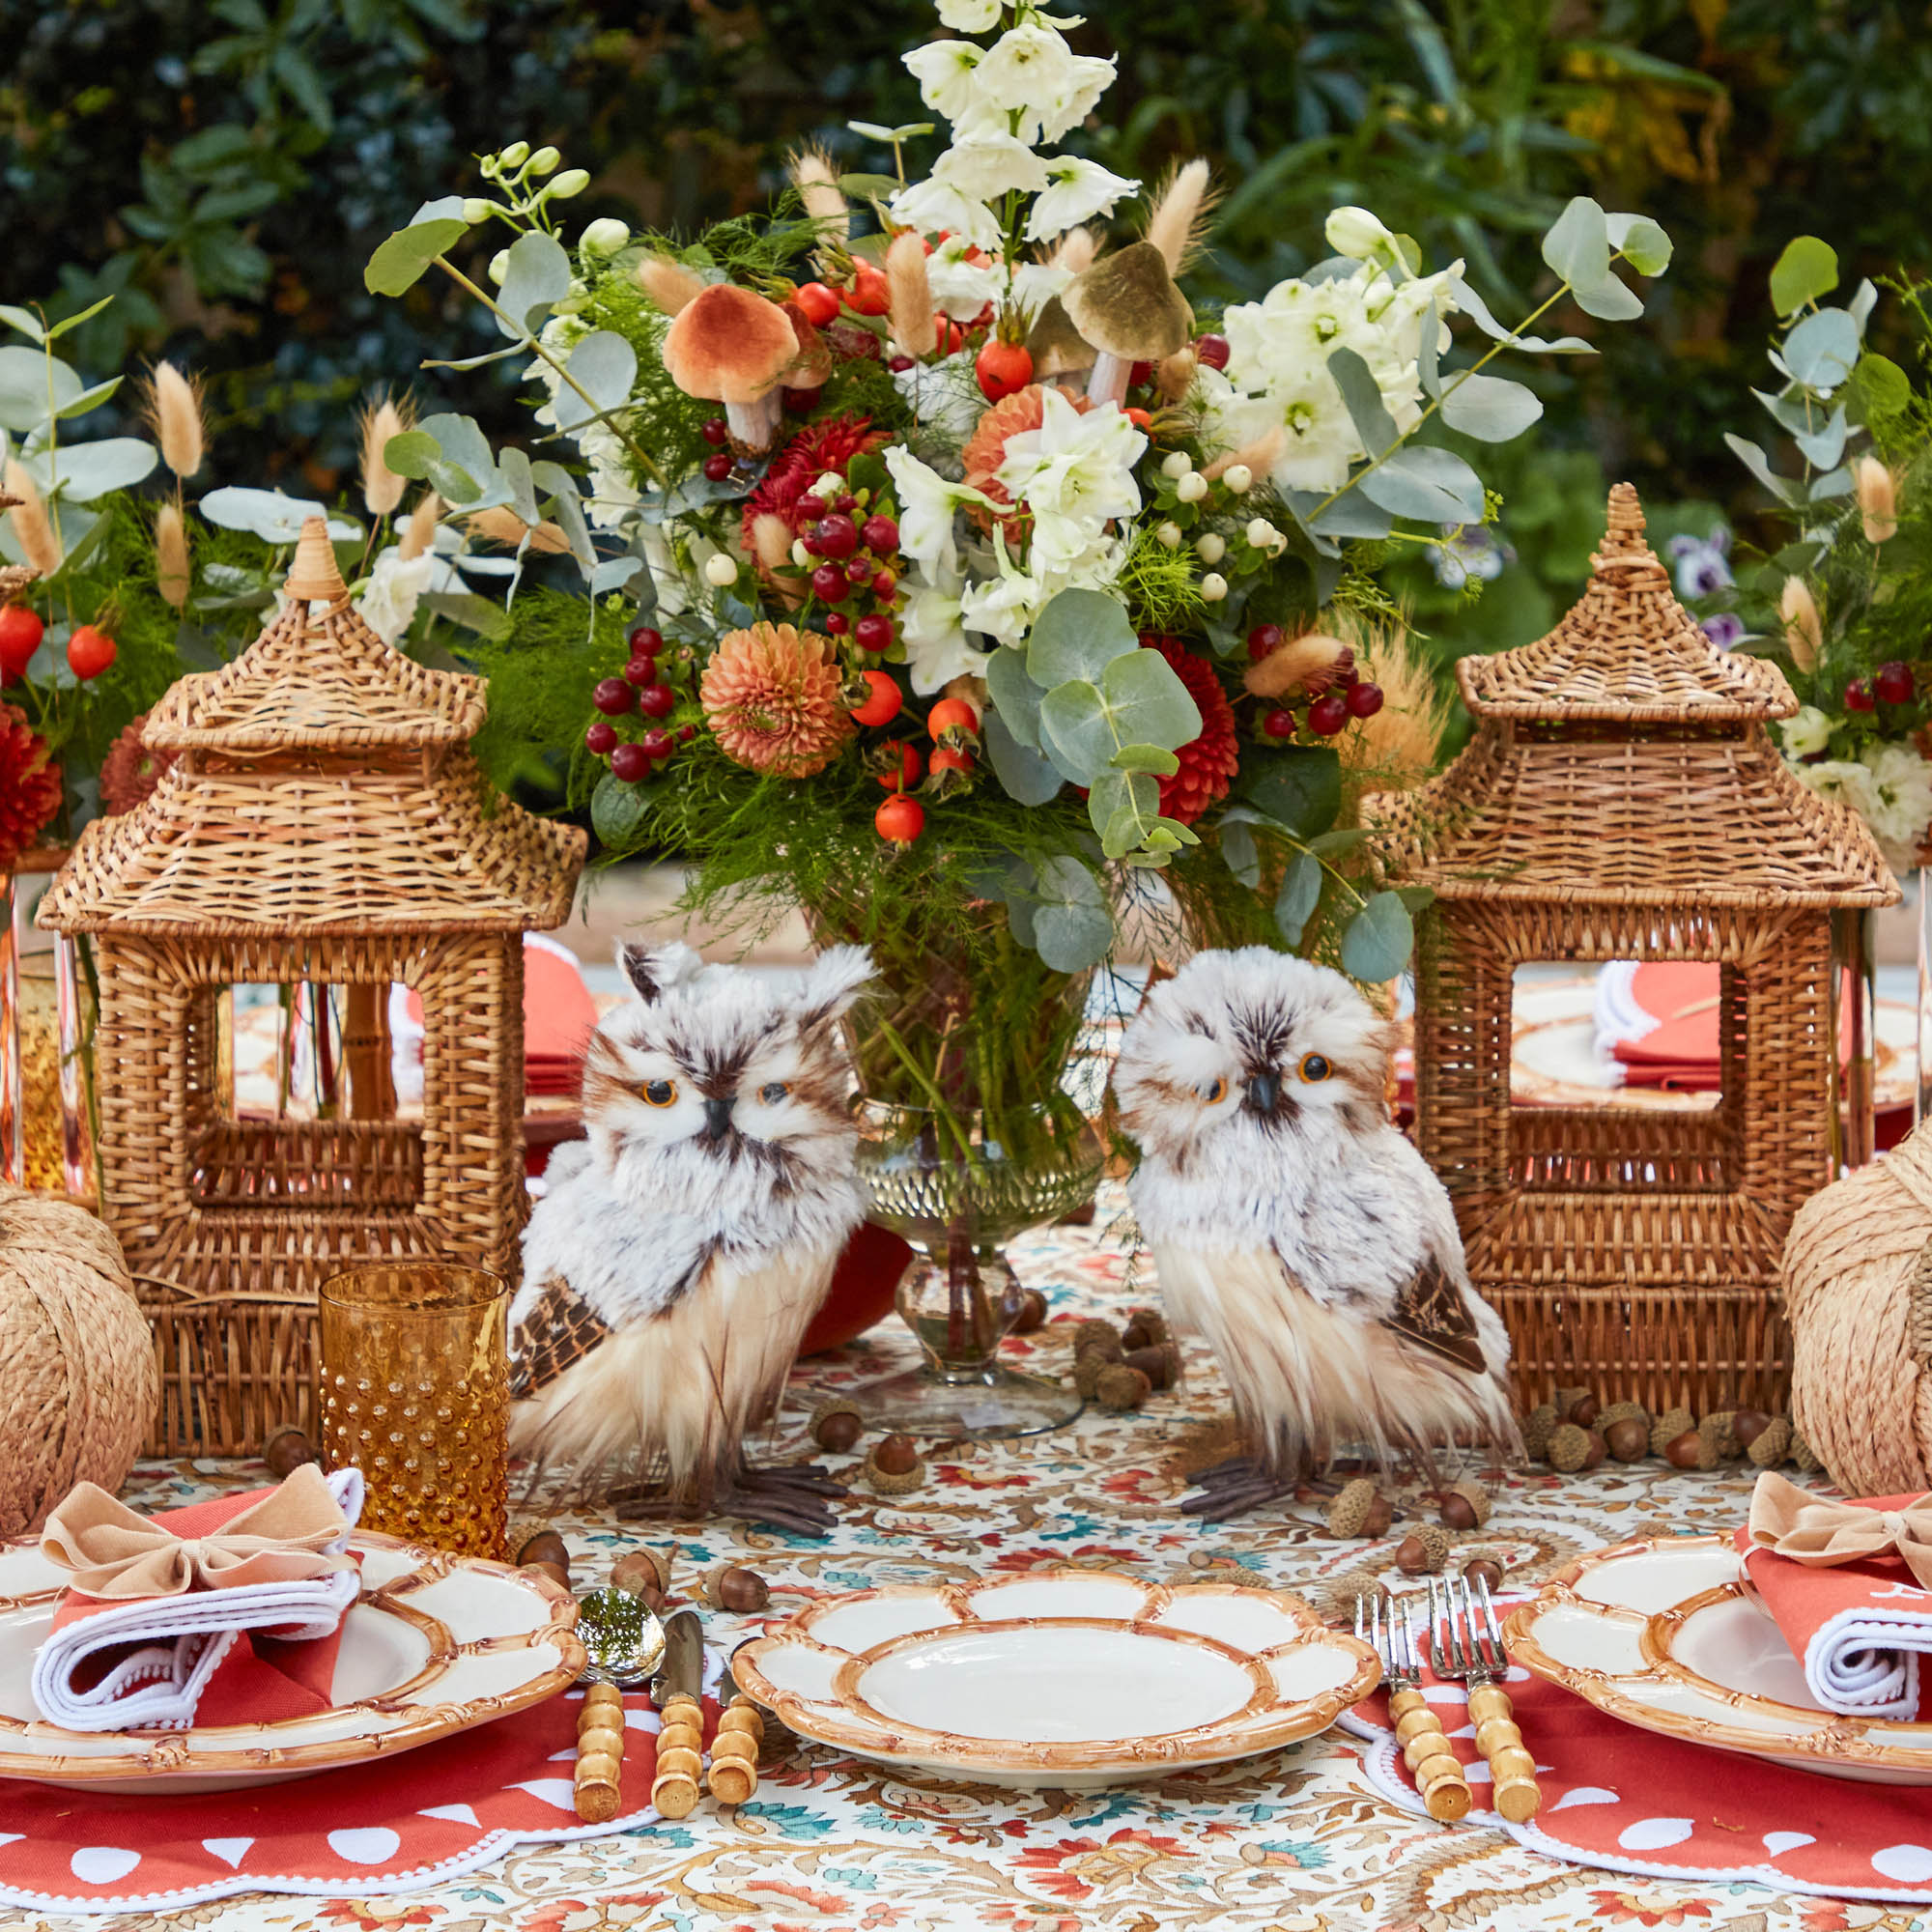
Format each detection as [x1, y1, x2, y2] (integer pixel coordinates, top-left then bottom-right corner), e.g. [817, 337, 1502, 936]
[1370, 483, 1899, 1414]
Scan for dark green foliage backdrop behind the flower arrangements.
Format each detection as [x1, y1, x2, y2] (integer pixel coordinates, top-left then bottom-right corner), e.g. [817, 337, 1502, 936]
[0, 0, 1932, 618]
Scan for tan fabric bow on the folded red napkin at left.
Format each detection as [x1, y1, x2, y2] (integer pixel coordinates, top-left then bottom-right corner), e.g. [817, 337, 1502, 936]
[41, 1463, 355, 1598]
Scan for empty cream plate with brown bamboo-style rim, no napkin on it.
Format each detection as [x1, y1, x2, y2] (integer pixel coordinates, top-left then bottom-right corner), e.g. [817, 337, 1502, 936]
[732, 1569, 1378, 1791]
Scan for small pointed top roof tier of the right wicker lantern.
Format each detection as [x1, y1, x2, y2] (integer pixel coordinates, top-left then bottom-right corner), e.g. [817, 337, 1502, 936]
[1455, 483, 1799, 724]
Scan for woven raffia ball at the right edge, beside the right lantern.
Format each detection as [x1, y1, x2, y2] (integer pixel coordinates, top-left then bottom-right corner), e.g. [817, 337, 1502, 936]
[1779, 1126, 1932, 1495]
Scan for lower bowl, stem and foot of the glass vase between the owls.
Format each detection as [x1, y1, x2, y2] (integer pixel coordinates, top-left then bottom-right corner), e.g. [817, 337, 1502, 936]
[852, 1101, 1105, 1437]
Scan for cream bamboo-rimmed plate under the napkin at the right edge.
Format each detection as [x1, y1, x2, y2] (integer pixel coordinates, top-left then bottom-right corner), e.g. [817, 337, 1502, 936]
[1507, 1536, 1932, 1785]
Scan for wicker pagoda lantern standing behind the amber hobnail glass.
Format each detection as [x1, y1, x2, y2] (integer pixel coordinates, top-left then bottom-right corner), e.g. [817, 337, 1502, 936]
[39, 518, 585, 1453]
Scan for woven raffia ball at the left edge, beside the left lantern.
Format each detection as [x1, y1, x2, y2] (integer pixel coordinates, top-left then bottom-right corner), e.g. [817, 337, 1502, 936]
[0, 1186, 160, 1536]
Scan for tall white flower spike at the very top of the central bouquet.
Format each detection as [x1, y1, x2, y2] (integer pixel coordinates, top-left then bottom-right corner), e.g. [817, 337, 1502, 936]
[891, 0, 1140, 321]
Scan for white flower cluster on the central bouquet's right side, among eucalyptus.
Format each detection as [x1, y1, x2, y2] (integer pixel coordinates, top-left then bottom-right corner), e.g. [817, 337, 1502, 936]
[1200, 209, 1463, 491]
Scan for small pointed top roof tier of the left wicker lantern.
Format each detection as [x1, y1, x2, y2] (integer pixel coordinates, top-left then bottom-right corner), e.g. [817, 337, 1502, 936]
[143, 518, 483, 755]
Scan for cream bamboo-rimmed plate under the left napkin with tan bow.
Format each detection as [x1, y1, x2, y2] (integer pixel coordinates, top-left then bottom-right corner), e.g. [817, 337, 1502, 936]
[0, 1530, 583, 1793]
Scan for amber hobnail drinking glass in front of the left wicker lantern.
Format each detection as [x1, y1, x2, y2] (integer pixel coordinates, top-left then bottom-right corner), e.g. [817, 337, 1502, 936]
[319, 1262, 510, 1559]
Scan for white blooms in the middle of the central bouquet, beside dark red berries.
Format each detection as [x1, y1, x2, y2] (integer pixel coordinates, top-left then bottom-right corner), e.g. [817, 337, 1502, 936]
[885, 386, 1148, 696]
